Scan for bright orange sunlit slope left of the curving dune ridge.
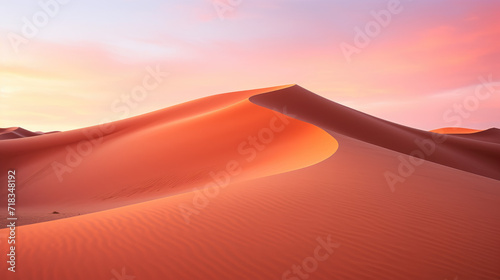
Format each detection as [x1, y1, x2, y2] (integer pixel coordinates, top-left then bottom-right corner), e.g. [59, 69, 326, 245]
[0, 84, 337, 223]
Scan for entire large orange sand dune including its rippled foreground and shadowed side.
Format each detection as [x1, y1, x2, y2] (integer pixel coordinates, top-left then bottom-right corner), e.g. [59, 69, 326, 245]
[0, 85, 500, 280]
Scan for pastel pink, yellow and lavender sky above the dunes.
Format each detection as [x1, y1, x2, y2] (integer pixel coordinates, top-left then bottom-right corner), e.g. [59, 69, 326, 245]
[0, 0, 500, 131]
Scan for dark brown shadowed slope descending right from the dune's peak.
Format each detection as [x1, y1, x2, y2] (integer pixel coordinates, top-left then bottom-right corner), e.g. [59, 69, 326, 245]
[250, 85, 500, 180]
